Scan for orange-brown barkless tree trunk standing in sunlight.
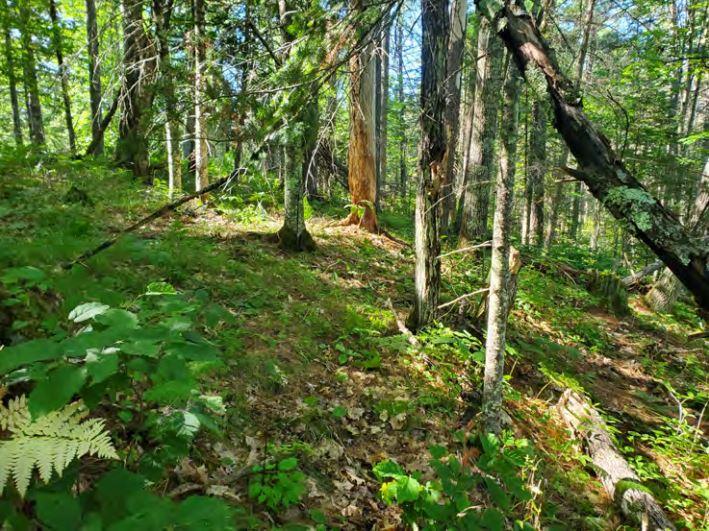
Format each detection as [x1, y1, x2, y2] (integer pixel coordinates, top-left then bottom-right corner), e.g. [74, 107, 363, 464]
[345, 4, 379, 232]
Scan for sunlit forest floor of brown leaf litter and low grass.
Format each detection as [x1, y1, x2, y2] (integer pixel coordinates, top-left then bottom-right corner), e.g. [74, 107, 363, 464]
[0, 161, 709, 529]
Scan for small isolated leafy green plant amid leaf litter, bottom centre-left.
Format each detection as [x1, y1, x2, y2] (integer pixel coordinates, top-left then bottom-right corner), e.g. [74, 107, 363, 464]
[249, 457, 305, 509]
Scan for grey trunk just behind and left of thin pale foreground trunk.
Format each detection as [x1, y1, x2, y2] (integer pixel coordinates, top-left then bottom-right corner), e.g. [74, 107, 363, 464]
[459, 19, 502, 241]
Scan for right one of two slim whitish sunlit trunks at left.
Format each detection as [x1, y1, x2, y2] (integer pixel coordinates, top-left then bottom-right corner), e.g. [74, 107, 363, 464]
[193, 0, 209, 192]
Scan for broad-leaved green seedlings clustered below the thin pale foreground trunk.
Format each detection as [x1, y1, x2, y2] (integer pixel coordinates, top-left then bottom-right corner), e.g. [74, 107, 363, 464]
[374, 434, 531, 530]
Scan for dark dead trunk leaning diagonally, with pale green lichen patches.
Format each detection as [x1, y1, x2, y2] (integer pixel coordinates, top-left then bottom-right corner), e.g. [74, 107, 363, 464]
[477, 0, 709, 312]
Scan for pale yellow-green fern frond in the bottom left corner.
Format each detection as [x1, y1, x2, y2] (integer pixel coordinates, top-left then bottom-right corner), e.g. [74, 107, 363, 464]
[0, 395, 118, 497]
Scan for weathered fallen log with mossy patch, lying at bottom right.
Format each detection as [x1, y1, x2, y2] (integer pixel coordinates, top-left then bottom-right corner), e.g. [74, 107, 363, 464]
[557, 389, 675, 531]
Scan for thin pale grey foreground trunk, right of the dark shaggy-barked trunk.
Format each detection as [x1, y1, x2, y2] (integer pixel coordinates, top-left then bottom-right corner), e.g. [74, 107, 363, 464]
[483, 60, 520, 434]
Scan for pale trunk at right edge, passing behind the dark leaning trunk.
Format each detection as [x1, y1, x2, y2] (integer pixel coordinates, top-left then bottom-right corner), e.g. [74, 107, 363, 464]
[645, 158, 709, 312]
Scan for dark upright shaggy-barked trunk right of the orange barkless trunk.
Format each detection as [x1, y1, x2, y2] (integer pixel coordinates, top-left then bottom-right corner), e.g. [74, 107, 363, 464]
[408, 0, 449, 330]
